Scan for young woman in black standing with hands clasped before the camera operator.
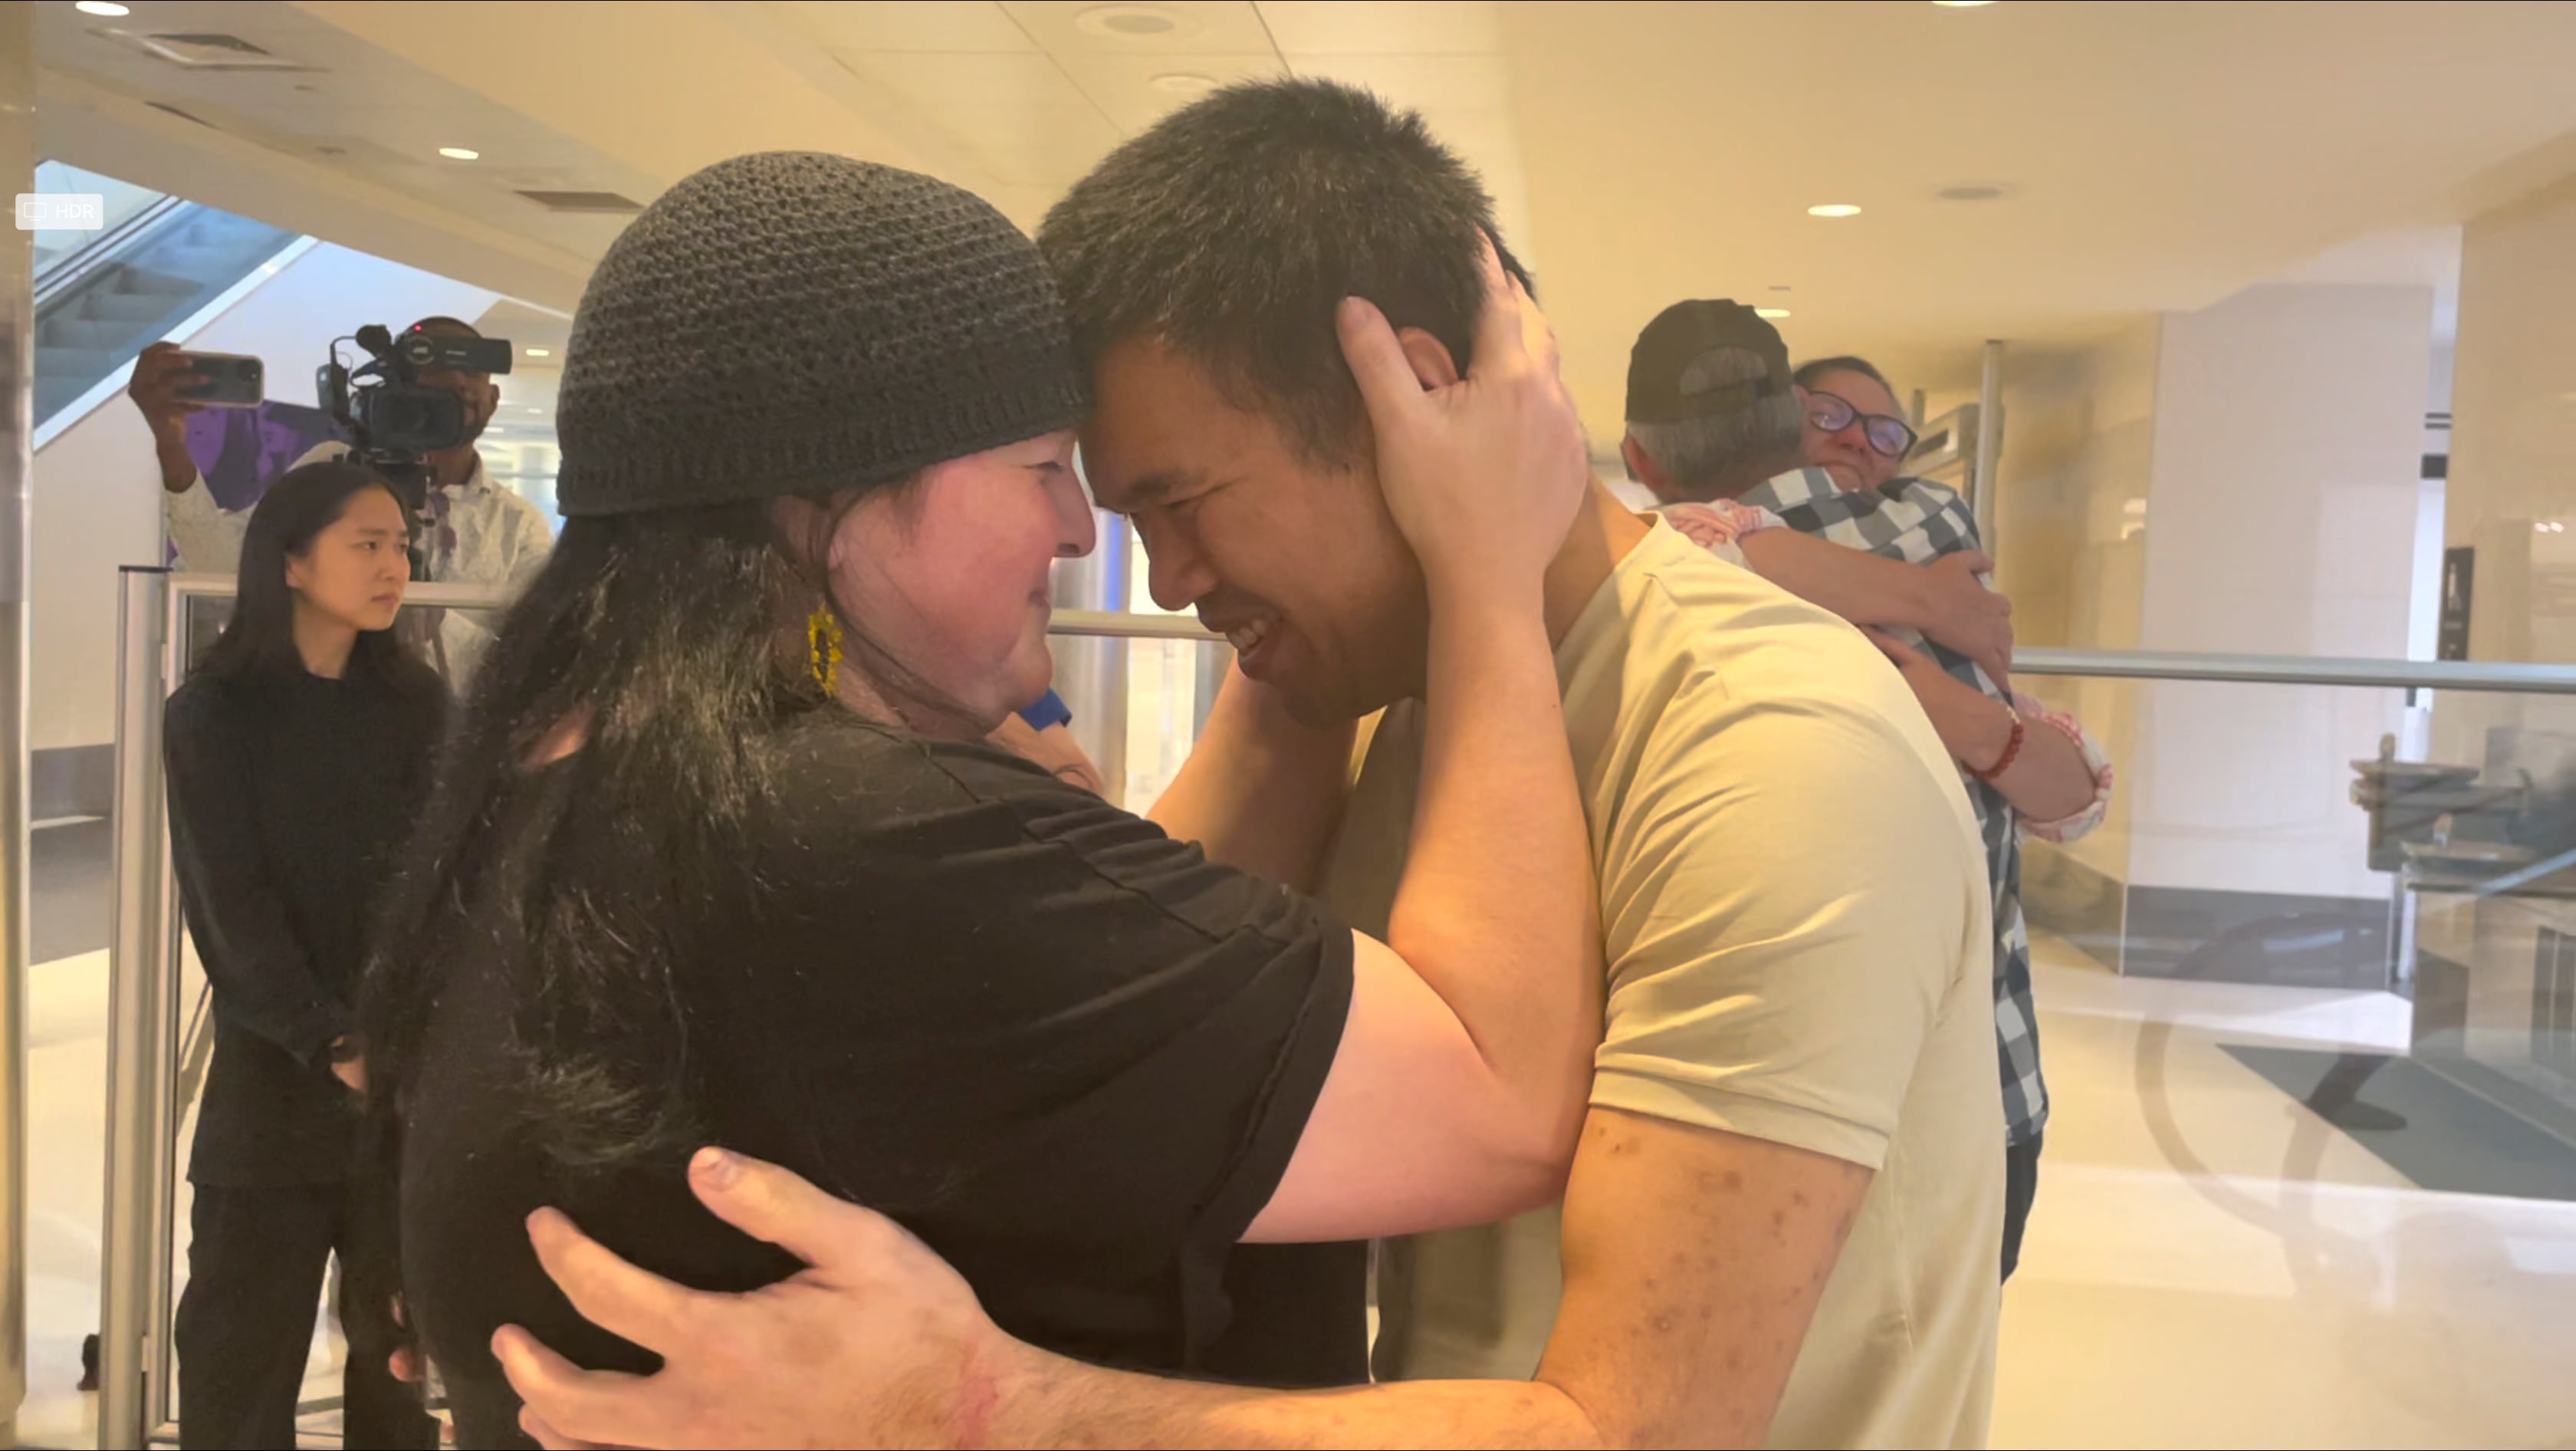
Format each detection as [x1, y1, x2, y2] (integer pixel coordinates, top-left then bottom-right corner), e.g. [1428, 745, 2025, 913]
[163, 462, 445, 1449]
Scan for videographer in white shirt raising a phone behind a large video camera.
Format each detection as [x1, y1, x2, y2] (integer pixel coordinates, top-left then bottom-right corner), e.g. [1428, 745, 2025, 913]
[127, 317, 554, 608]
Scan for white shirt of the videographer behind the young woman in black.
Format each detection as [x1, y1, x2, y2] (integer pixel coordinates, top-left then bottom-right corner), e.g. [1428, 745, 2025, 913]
[163, 443, 554, 683]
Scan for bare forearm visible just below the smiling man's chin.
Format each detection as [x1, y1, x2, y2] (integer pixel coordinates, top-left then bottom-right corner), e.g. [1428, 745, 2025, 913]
[1129, 670, 1352, 892]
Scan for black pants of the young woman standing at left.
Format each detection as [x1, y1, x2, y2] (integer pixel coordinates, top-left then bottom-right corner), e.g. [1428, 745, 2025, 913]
[178, 1178, 438, 1451]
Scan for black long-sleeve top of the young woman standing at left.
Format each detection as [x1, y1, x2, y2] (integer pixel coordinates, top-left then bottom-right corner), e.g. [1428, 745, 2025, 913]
[163, 673, 443, 1186]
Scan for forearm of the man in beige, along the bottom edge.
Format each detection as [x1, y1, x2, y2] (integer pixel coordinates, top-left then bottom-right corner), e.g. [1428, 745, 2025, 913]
[989, 1351, 1605, 1449]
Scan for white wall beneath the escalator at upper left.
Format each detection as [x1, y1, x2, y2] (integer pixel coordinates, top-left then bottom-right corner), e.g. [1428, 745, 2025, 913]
[28, 242, 497, 750]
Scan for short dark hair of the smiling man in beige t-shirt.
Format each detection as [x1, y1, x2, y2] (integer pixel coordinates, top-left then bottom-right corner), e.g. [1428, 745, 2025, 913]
[1038, 80, 1536, 464]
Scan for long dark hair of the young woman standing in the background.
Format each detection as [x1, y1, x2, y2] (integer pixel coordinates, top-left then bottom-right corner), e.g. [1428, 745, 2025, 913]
[196, 459, 443, 699]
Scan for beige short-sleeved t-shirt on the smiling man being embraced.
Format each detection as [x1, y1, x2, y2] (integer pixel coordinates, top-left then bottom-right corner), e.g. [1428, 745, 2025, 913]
[1324, 523, 2004, 1446]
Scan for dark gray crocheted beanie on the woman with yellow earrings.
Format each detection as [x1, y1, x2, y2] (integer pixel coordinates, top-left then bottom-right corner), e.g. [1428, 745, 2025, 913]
[557, 152, 1089, 518]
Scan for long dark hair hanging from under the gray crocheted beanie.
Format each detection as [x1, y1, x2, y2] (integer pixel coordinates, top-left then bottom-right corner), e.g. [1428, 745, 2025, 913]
[360, 485, 902, 1175]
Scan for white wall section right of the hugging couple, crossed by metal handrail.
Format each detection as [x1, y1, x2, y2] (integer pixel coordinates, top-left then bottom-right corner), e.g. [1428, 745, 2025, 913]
[2131, 286, 2434, 897]
